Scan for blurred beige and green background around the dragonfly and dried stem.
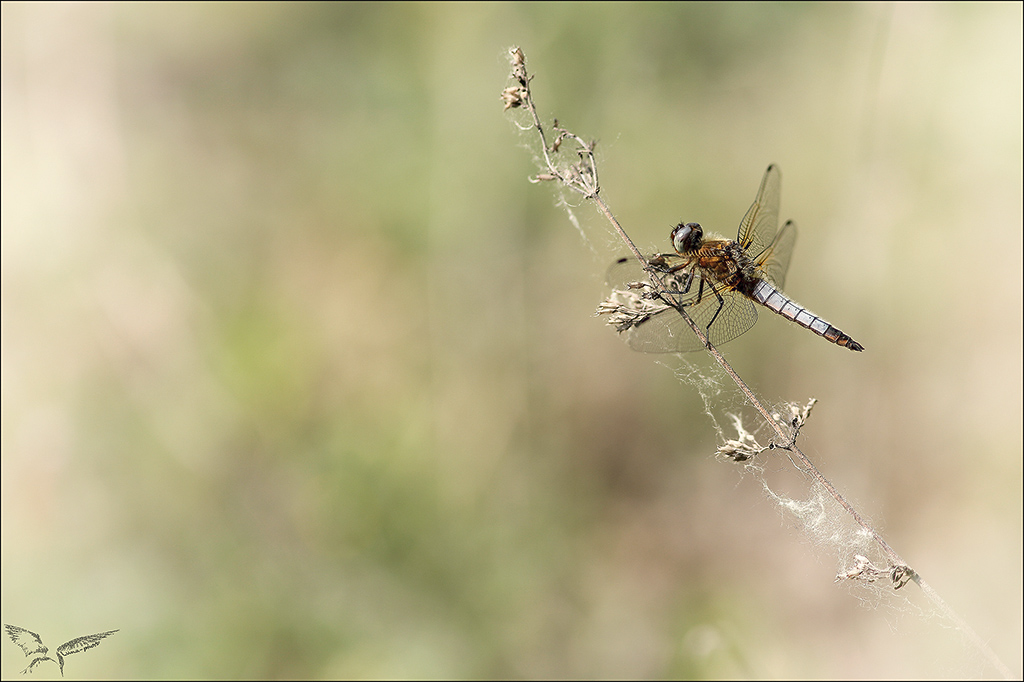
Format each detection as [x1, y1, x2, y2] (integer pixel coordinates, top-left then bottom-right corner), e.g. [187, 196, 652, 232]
[0, 3, 1022, 678]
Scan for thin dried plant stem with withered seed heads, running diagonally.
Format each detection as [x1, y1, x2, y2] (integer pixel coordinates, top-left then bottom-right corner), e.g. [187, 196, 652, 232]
[502, 47, 1014, 679]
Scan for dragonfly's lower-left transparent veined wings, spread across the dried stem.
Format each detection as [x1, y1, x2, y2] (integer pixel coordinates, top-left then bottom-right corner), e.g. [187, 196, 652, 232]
[598, 254, 758, 353]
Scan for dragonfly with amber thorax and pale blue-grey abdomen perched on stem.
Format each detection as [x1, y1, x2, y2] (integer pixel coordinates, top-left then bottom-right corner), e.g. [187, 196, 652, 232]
[597, 165, 864, 353]
